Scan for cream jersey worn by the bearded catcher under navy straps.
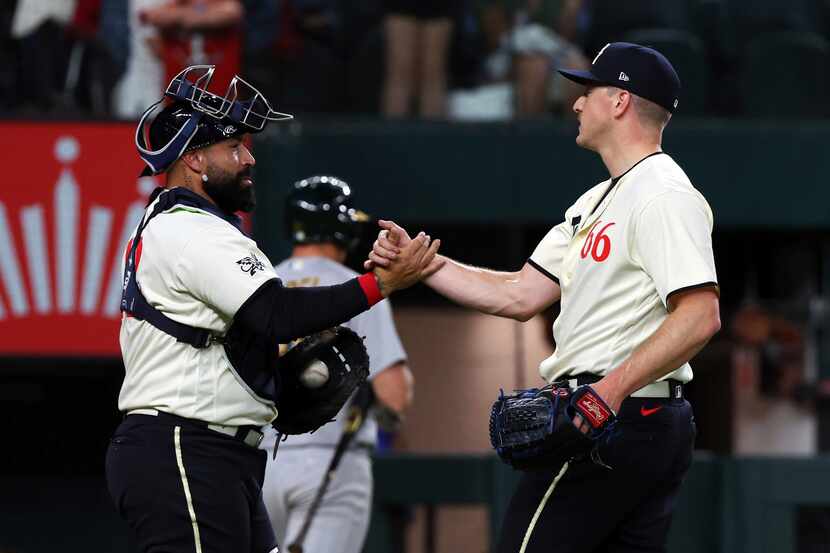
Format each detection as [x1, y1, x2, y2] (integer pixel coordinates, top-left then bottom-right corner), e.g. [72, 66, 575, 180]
[118, 190, 277, 426]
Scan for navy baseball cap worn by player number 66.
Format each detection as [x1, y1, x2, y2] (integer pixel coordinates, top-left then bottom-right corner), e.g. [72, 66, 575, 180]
[559, 42, 680, 113]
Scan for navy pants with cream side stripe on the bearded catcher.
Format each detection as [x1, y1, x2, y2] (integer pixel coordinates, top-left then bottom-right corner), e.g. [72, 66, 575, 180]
[106, 415, 277, 553]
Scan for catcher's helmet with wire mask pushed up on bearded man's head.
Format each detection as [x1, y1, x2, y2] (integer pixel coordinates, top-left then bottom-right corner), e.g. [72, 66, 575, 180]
[135, 65, 293, 176]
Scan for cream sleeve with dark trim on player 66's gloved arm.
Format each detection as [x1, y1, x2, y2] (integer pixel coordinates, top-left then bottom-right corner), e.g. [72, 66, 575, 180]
[632, 191, 717, 305]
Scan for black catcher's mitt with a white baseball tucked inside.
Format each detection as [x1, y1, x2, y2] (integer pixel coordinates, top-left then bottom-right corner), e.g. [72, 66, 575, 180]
[273, 326, 369, 435]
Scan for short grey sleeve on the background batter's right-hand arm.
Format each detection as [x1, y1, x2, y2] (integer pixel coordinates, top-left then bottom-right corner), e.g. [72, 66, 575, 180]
[349, 300, 406, 378]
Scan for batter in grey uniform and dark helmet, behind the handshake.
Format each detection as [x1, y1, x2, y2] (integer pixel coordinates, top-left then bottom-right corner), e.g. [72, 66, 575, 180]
[262, 176, 413, 553]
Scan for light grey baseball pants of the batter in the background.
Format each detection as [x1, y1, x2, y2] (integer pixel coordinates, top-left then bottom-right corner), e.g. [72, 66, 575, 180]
[262, 446, 372, 553]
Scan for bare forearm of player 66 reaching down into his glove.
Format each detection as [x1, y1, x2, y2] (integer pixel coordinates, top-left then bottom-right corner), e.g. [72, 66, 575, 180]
[606, 294, 720, 399]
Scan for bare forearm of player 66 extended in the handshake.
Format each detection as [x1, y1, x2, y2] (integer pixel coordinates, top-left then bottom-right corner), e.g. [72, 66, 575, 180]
[424, 257, 535, 321]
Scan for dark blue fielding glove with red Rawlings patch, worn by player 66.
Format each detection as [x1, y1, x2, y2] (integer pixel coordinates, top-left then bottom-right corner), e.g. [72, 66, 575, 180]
[490, 384, 615, 470]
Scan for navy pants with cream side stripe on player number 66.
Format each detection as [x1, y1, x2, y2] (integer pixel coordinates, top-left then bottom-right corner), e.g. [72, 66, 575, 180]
[497, 398, 695, 553]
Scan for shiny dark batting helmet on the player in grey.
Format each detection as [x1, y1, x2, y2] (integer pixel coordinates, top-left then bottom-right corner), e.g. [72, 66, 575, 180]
[285, 176, 370, 250]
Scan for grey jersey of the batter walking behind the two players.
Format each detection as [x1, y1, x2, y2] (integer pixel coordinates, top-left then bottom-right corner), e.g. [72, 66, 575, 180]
[261, 257, 406, 450]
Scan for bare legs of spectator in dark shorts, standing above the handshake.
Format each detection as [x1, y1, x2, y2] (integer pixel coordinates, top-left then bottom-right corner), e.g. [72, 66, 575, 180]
[383, 0, 455, 118]
